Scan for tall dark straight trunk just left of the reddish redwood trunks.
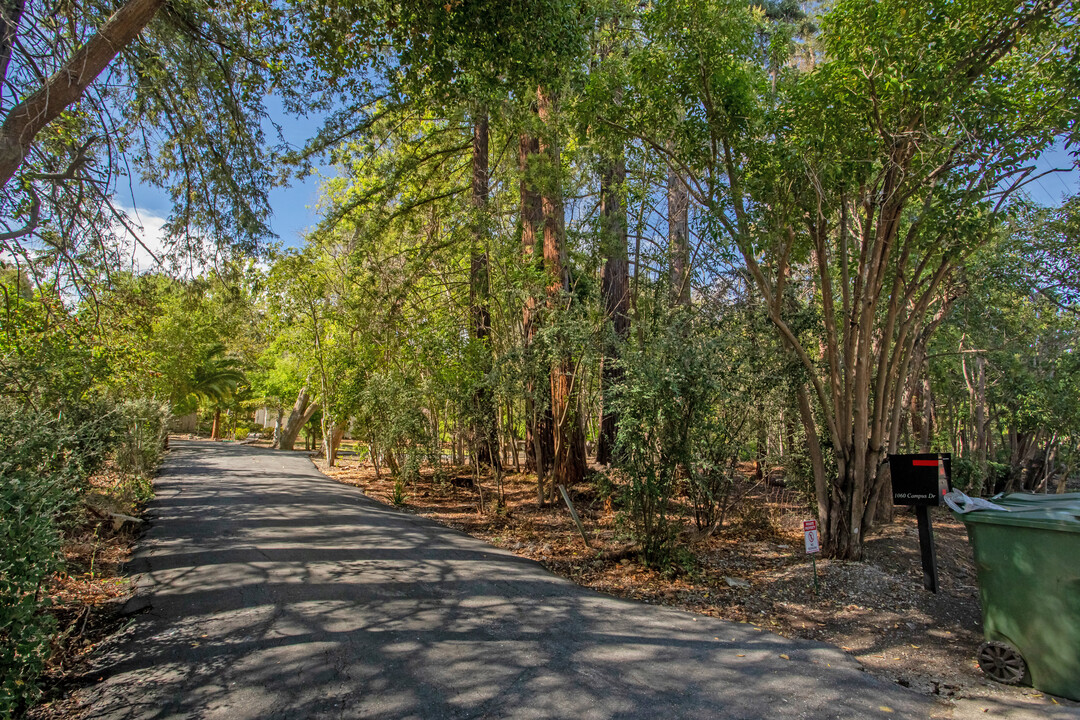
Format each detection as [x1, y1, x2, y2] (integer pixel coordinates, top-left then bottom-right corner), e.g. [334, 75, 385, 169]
[469, 111, 500, 468]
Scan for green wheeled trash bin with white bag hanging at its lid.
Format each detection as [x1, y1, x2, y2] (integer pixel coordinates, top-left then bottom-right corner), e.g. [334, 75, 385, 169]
[958, 493, 1080, 701]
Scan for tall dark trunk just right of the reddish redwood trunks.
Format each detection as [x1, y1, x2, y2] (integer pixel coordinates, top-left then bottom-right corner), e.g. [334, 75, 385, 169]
[596, 150, 630, 465]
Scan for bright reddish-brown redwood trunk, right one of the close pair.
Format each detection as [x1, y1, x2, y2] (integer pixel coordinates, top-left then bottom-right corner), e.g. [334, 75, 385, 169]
[537, 87, 585, 495]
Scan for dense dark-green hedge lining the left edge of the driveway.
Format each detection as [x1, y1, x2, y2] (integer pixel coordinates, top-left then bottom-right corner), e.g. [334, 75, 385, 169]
[0, 400, 168, 717]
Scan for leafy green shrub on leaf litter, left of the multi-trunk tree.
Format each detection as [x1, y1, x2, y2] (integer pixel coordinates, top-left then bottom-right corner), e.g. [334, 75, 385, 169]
[612, 303, 753, 567]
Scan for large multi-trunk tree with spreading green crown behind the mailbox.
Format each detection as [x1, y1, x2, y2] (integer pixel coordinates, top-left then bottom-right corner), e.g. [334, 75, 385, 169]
[606, 0, 1078, 558]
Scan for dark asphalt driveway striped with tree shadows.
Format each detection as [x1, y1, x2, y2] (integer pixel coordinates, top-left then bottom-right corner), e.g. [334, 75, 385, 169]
[78, 443, 942, 720]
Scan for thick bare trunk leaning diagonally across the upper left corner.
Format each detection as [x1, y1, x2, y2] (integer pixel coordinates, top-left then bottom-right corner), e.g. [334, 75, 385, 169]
[0, 0, 165, 188]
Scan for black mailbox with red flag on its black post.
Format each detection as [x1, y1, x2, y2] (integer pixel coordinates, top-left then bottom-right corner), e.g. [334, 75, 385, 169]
[889, 452, 953, 593]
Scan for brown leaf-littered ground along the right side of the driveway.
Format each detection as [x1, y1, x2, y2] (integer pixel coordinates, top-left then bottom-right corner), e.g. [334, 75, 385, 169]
[315, 457, 1080, 717]
